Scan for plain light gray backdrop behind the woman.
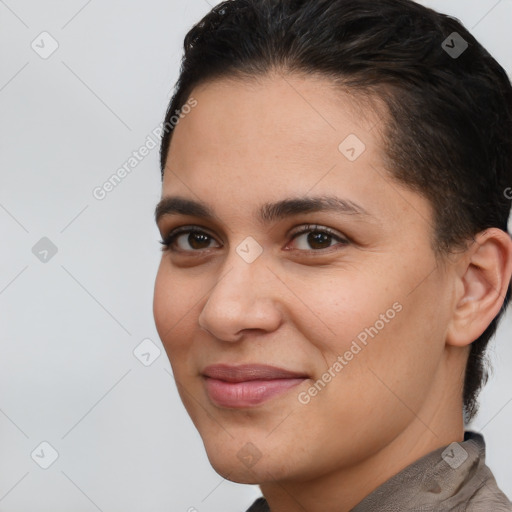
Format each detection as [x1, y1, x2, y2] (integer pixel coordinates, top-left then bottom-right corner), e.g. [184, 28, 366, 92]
[0, 0, 512, 512]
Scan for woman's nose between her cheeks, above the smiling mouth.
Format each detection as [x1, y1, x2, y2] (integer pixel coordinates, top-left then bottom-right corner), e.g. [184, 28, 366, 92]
[198, 252, 282, 341]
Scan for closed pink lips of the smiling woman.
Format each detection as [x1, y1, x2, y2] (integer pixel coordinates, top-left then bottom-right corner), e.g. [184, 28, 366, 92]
[203, 364, 308, 408]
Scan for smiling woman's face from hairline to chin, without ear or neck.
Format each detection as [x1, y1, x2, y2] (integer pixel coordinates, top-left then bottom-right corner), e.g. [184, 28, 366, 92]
[154, 75, 453, 483]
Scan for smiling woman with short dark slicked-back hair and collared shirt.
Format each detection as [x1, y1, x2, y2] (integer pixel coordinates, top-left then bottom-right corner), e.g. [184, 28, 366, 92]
[154, 0, 512, 512]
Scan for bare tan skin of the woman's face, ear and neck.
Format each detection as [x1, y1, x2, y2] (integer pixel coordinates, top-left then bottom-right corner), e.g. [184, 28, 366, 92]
[154, 73, 512, 512]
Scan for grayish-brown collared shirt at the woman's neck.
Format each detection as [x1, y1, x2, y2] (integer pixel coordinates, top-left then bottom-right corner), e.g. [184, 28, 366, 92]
[247, 431, 512, 512]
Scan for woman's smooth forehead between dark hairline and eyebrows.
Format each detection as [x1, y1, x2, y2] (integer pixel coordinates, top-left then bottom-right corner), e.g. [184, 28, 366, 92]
[162, 75, 430, 235]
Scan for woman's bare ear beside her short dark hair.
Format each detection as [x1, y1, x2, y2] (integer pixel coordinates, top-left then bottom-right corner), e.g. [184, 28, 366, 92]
[446, 228, 512, 347]
